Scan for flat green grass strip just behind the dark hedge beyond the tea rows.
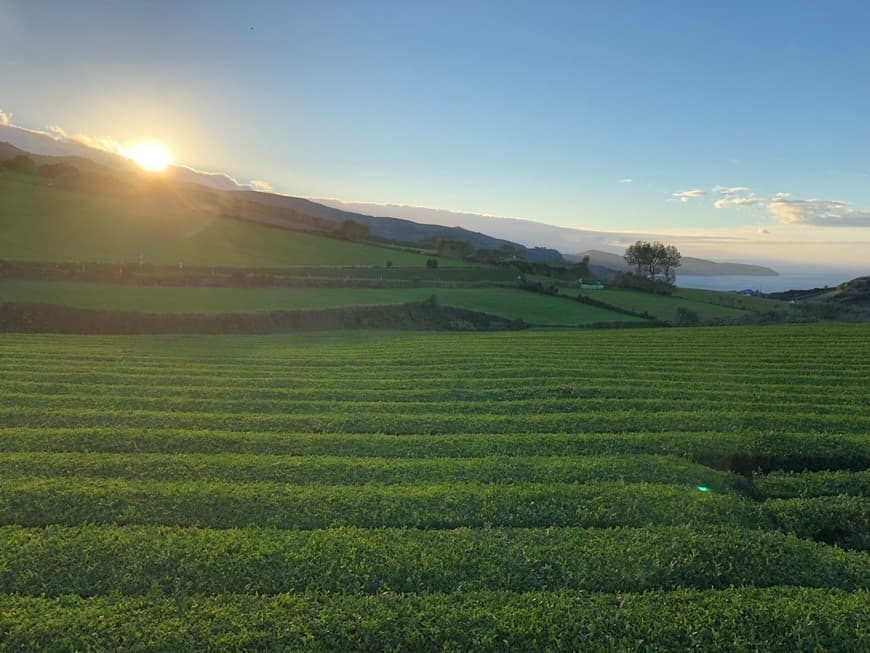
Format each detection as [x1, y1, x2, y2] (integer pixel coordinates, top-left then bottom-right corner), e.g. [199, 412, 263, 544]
[0, 281, 642, 325]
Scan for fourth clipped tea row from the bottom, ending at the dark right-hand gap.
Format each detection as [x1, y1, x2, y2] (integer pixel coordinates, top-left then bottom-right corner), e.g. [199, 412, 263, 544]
[0, 452, 743, 492]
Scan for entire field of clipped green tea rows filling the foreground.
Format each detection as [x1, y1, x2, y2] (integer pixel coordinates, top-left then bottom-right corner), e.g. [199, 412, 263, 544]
[0, 325, 870, 651]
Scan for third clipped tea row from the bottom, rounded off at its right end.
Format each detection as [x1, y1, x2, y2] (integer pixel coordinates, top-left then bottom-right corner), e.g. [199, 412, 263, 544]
[0, 479, 762, 529]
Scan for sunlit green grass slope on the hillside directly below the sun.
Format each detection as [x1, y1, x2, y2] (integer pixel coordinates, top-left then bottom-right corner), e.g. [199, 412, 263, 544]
[0, 173, 467, 267]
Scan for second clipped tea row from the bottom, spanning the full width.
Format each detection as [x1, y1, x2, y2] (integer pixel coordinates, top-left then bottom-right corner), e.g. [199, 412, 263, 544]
[0, 525, 870, 596]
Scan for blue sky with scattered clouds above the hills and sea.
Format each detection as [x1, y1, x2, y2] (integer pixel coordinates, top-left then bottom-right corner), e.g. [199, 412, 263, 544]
[0, 0, 870, 264]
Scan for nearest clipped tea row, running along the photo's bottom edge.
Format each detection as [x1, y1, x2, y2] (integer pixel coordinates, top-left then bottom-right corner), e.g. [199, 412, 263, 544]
[0, 587, 870, 653]
